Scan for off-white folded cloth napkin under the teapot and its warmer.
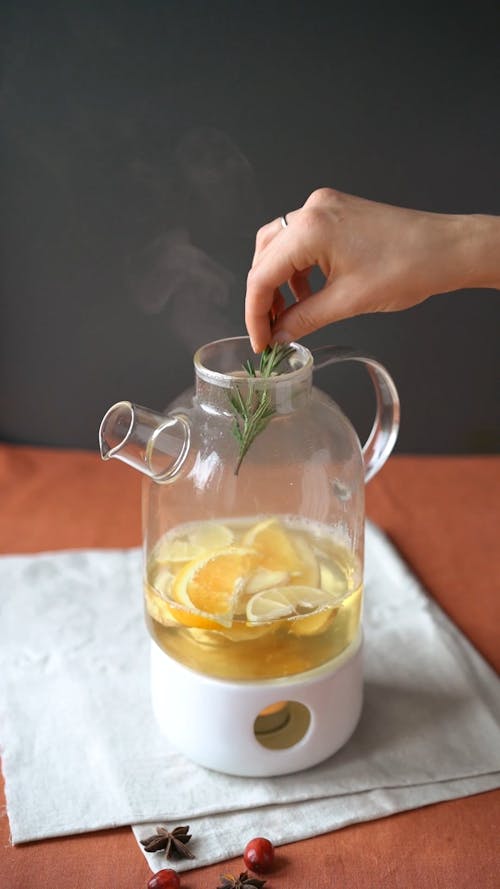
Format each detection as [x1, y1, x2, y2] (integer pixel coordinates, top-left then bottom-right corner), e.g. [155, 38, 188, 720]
[0, 525, 500, 870]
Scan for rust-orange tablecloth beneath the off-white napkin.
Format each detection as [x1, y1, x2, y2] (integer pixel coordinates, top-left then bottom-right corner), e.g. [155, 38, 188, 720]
[0, 445, 500, 889]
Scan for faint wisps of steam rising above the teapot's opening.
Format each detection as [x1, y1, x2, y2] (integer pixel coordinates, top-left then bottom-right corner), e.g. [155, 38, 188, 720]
[129, 128, 256, 352]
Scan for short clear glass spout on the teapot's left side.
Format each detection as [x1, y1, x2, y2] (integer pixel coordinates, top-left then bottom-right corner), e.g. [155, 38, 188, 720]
[99, 401, 190, 482]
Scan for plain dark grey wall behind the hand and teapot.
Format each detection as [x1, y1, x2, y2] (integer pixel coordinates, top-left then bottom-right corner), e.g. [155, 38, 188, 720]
[0, 0, 500, 452]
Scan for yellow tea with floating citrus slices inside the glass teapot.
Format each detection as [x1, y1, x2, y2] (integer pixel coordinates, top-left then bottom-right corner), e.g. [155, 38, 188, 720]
[145, 516, 361, 680]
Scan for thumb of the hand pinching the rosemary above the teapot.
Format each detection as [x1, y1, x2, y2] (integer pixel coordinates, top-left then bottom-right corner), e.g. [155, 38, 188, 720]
[273, 279, 358, 343]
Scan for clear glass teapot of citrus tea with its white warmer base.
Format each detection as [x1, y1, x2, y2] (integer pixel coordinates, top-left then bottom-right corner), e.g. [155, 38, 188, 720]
[99, 337, 399, 775]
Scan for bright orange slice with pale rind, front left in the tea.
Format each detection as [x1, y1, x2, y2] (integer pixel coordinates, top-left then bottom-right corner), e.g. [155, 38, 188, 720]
[172, 546, 257, 625]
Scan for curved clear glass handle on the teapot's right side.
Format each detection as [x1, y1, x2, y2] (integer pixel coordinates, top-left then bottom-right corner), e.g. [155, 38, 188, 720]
[311, 346, 400, 481]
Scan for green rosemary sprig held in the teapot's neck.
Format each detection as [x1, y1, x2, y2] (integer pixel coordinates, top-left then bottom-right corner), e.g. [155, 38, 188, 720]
[229, 343, 294, 475]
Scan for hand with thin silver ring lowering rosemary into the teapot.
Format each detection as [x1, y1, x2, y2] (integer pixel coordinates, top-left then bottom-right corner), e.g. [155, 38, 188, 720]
[245, 188, 500, 352]
